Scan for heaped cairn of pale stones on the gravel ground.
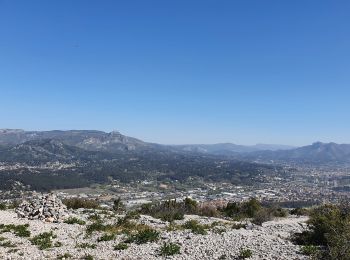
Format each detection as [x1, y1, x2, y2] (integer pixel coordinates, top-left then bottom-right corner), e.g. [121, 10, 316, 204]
[16, 194, 67, 222]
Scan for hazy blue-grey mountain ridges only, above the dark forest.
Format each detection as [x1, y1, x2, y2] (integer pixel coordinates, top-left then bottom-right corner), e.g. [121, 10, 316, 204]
[0, 129, 350, 164]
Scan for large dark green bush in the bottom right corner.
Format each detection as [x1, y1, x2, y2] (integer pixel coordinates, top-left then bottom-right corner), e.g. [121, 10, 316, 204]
[293, 202, 350, 260]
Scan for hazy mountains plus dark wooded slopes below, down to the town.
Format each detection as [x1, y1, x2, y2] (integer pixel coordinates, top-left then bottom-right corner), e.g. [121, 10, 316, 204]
[0, 129, 350, 190]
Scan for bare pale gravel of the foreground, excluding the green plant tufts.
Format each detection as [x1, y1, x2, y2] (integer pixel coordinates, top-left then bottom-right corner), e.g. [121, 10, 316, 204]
[0, 210, 307, 260]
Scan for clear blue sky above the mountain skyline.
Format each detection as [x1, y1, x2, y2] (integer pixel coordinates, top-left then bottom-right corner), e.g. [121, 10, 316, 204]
[0, 0, 350, 145]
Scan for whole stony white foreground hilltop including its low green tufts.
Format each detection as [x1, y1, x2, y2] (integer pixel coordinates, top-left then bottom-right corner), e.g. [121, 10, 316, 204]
[0, 207, 308, 260]
